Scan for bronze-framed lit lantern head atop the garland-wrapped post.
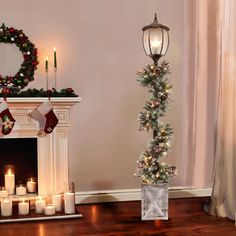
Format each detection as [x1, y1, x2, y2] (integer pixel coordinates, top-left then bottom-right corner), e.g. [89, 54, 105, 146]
[142, 13, 169, 65]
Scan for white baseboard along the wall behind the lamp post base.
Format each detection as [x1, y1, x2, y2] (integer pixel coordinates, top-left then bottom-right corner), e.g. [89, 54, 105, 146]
[76, 187, 212, 204]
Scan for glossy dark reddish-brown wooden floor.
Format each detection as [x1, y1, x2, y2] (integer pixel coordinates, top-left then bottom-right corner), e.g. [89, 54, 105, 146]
[0, 198, 236, 236]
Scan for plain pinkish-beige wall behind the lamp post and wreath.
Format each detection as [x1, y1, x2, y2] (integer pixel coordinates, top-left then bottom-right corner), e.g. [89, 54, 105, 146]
[0, 0, 186, 191]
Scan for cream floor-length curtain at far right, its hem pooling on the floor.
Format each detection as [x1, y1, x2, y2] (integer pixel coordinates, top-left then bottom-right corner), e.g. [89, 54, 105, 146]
[210, 0, 236, 220]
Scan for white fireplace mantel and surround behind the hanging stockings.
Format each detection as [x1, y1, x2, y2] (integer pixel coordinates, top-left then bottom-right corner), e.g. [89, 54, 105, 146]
[0, 97, 82, 195]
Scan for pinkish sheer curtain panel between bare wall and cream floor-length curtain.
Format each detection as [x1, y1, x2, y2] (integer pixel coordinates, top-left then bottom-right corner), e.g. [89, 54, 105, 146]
[183, 0, 220, 188]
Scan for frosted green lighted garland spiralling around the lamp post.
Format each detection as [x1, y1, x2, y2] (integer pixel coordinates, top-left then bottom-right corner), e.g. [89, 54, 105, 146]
[135, 62, 177, 184]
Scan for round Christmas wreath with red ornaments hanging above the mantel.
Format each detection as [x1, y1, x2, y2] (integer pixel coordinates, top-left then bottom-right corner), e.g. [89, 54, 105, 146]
[0, 24, 38, 90]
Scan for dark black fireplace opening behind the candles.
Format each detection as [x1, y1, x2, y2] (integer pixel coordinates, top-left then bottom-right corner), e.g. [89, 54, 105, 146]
[0, 138, 38, 189]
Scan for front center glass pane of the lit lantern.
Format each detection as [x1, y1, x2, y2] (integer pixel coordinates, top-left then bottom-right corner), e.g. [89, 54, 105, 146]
[150, 28, 163, 55]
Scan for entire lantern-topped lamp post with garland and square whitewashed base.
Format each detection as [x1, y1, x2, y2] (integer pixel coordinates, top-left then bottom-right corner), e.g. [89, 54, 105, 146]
[135, 14, 176, 220]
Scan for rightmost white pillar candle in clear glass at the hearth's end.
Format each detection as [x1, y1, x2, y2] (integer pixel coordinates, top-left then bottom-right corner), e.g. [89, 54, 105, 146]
[64, 182, 75, 214]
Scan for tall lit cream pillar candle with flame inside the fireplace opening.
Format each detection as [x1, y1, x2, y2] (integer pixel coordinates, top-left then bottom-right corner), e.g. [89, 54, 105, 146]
[4, 165, 15, 194]
